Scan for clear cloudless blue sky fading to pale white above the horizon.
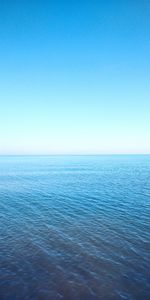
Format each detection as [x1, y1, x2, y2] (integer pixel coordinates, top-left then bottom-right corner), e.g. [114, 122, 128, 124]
[0, 0, 150, 154]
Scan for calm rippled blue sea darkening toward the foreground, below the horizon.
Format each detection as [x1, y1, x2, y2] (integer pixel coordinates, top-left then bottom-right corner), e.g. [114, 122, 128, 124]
[0, 155, 150, 300]
